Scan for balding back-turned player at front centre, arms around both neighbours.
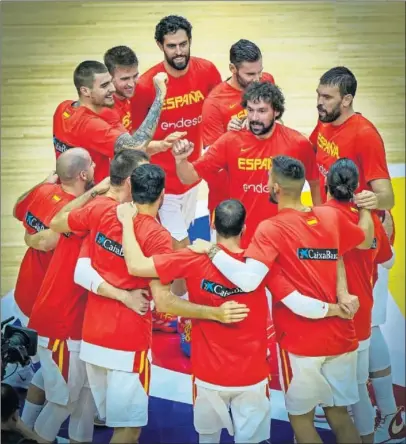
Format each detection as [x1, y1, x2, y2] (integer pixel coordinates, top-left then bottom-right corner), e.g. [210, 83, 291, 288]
[118, 199, 354, 442]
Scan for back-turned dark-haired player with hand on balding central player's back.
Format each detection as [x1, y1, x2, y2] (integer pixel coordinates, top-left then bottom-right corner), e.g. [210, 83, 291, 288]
[65, 165, 245, 442]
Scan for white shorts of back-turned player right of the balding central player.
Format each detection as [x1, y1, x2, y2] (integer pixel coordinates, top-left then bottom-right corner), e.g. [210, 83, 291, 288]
[277, 347, 358, 415]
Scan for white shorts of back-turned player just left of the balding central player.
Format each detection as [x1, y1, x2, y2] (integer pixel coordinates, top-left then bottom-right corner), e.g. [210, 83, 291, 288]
[86, 361, 151, 427]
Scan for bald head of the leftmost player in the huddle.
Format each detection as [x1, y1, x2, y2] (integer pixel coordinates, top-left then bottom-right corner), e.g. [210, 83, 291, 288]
[56, 148, 92, 183]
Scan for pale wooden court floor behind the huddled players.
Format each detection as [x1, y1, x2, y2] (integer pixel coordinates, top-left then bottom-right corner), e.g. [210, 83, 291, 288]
[0, 1, 405, 295]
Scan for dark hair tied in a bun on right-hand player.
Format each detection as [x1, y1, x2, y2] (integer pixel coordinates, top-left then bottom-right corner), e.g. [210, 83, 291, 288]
[327, 157, 359, 202]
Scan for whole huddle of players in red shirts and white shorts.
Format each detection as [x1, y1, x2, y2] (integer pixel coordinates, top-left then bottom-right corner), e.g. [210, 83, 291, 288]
[6, 15, 405, 443]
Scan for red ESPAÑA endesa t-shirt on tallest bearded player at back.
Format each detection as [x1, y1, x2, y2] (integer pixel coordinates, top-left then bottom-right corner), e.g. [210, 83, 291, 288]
[132, 57, 221, 194]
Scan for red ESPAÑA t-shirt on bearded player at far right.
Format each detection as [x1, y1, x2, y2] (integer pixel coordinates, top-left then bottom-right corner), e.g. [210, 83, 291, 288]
[310, 113, 390, 202]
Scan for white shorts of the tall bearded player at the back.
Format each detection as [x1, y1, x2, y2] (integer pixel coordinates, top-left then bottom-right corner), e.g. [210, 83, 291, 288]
[159, 185, 199, 242]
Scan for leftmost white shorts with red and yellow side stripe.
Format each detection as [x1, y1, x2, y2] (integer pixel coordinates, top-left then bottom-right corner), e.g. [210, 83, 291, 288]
[38, 340, 87, 406]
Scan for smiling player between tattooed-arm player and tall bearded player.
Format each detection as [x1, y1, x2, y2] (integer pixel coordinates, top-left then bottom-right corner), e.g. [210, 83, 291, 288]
[100, 46, 139, 134]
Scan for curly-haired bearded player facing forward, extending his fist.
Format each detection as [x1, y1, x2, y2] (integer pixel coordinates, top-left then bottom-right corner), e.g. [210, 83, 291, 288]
[173, 82, 319, 248]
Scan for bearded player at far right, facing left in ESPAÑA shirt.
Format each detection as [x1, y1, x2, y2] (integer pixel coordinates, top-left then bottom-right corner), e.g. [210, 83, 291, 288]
[310, 66, 395, 210]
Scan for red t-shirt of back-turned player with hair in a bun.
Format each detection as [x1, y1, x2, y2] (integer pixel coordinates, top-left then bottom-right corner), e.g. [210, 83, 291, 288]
[325, 199, 386, 341]
